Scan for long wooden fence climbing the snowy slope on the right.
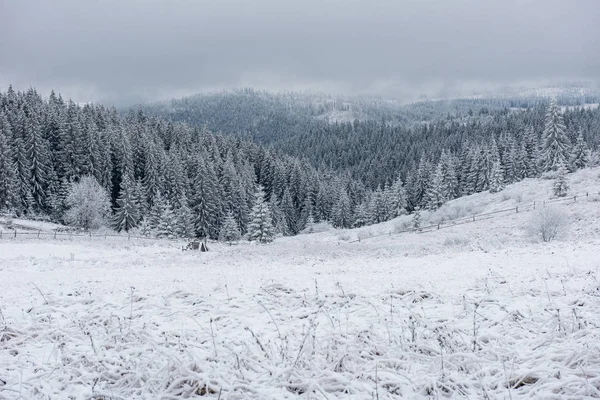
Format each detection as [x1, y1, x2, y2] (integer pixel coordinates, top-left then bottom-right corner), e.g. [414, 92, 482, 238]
[347, 192, 600, 243]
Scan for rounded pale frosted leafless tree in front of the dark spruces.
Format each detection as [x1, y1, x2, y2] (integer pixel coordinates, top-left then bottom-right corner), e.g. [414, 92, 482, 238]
[65, 176, 110, 231]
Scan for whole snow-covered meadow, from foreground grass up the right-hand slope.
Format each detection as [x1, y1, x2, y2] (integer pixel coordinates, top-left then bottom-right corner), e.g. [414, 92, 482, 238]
[0, 169, 600, 399]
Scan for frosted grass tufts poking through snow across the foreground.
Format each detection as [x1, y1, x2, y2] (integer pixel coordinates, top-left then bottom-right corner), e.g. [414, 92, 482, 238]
[0, 264, 600, 399]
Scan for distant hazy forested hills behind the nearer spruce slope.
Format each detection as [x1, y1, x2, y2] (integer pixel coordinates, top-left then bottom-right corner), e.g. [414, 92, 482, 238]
[142, 90, 600, 189]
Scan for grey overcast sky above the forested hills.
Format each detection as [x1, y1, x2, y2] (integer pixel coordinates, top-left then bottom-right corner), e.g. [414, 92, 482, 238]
[0, 0, 600, 104]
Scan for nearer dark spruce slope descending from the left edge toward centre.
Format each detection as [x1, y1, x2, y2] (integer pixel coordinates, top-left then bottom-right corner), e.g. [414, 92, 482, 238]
[0, 88, 366, 238]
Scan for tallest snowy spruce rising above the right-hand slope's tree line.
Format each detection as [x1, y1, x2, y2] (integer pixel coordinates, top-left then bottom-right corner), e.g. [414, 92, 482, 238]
[540, 100, 570, 171]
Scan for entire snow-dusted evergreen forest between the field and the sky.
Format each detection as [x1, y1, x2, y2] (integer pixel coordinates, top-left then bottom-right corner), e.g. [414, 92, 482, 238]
[0, 88, 600, 241]
